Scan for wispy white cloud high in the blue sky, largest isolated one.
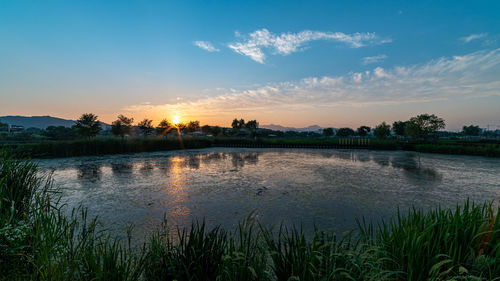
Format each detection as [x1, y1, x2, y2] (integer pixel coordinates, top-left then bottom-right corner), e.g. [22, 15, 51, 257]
[228, 28, 392, 63]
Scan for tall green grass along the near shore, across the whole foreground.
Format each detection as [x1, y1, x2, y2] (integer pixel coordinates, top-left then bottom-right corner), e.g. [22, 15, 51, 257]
[0, 156, 500, 281]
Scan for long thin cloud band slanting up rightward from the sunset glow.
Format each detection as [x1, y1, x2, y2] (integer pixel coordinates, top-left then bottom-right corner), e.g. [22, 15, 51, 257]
[125, 49, 500, 118]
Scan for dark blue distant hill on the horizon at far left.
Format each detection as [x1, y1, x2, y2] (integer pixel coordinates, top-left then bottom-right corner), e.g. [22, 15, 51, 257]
[0, 116, 110, 129]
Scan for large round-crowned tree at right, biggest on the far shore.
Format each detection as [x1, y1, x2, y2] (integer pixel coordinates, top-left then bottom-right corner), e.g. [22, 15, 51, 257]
[405, 114, 445, 137]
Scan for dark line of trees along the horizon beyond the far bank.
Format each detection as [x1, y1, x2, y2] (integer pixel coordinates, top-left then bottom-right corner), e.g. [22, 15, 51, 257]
[0, 113, 492, 140]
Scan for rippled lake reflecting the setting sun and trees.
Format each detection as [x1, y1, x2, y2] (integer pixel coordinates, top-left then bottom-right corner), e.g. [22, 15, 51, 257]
[38, 148, 500, 239]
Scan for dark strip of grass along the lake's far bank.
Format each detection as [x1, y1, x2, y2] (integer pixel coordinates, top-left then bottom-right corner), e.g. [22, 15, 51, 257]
[2, 136, 500, 158]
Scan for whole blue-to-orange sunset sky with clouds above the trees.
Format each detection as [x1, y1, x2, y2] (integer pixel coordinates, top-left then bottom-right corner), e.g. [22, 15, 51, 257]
[0, 0, 500, 130]
